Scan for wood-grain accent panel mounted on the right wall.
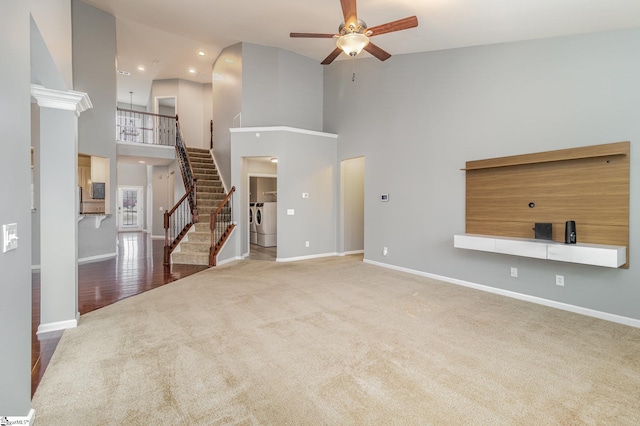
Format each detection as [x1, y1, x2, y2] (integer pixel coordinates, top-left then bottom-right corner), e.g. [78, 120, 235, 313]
[465, 142, 630, 268]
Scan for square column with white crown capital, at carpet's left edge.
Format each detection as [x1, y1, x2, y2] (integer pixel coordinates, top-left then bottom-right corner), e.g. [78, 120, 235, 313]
[31, 85, 92, 333]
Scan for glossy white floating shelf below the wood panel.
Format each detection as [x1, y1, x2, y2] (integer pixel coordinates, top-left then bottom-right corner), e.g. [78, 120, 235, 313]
[453, 234, 627, 268]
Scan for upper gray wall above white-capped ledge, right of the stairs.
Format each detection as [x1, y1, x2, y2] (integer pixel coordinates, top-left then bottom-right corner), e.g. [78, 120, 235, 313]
[213, 43, 323, 190]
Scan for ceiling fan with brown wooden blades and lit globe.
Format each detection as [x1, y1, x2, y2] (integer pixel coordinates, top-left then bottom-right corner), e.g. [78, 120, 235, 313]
[290, 0, 418, 65]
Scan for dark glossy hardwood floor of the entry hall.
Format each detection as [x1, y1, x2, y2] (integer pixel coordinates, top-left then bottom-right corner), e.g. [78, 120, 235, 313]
[31, 232, 207, 396]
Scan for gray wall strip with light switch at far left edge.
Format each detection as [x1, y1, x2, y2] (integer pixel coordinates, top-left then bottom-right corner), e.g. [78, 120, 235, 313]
[0, 0, 31, 416]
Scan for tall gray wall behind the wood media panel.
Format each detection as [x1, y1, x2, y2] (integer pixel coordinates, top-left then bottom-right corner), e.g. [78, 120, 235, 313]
[324, 30, 640, 319]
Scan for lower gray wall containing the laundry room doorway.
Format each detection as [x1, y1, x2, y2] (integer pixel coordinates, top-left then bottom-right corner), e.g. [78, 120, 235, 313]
[231, 129, 338, 259]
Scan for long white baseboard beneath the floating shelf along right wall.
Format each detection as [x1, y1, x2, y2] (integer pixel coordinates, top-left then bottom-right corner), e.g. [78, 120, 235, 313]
[364, 259, 640, 328]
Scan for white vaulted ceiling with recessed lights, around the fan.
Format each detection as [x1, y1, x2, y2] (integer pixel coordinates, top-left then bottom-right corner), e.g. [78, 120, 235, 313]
[82, 0, 640, 105]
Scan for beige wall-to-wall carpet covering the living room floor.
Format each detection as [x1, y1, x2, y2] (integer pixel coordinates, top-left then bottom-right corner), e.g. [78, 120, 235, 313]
[32, 256, 640, 425]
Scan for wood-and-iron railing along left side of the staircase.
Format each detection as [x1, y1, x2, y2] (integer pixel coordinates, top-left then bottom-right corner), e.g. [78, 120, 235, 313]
[164, 115, 198, 265]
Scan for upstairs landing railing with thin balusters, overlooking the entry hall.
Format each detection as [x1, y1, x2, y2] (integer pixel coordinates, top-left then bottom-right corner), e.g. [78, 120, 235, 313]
[116, 108, 176, 146]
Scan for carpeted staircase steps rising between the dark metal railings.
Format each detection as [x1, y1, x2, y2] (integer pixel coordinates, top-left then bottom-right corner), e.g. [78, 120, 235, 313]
[171, 147, 225, 265]
